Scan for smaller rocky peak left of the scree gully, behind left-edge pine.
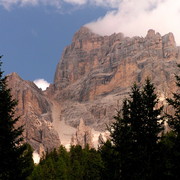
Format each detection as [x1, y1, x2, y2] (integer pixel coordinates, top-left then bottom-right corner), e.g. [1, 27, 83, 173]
[7, 73, 60, 154]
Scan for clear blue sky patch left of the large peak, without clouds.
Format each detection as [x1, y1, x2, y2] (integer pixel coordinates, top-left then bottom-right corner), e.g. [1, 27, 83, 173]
[0, 1, 107, 82]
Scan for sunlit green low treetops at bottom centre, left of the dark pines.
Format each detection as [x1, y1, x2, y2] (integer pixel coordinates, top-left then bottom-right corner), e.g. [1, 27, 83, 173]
[29, 146, 103, 180]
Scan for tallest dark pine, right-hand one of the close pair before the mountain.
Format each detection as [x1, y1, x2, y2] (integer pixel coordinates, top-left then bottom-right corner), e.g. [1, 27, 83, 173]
[138, 79, 164, 179]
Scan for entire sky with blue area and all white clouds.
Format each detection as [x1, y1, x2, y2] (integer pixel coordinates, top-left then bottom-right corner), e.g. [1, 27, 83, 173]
[0, 0, 180, 89]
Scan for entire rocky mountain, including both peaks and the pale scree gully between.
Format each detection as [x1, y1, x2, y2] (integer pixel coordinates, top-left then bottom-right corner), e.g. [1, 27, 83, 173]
[6, 27, 180, 153]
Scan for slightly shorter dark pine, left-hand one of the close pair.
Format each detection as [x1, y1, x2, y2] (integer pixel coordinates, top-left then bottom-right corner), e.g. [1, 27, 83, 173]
[110, 84, 142, 179]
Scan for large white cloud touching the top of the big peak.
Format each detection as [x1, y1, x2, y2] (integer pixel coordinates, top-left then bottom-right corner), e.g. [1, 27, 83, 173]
[87, 0, 180, 44]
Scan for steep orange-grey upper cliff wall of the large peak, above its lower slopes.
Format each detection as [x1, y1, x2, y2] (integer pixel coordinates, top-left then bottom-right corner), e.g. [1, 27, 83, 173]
[54, 27, 179, 102]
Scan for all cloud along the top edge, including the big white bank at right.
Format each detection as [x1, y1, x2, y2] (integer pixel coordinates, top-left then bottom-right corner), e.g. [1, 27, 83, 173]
[0, 0, 180, 45]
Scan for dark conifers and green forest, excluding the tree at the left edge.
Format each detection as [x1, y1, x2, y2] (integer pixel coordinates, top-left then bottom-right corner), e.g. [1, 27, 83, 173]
[29, 69, 180, 180]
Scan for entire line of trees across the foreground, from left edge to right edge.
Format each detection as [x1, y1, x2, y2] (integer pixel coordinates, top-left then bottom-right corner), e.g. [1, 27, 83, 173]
[0, 57, 180, 180]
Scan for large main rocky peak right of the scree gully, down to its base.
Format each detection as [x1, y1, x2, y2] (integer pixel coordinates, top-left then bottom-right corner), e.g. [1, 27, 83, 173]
[47, 27, 180, 130]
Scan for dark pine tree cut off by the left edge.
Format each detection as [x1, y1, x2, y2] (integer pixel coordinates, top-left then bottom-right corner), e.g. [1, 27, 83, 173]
[0, 57, 32, 180]
